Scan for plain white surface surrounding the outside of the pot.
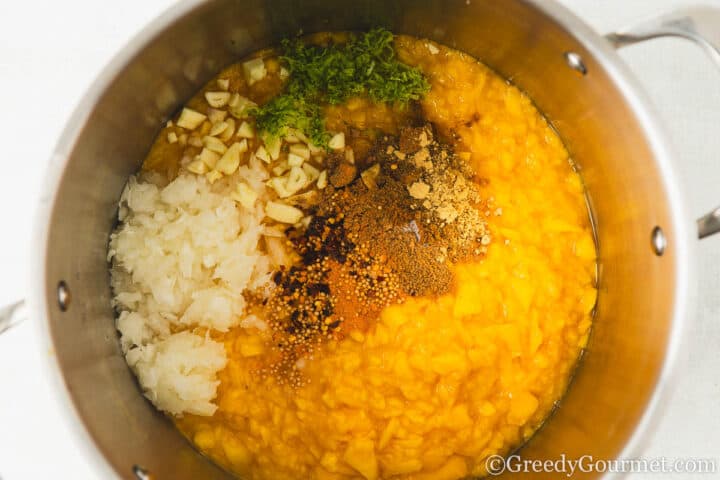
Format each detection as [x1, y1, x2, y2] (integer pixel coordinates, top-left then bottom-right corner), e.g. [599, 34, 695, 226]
[0, 0, 720, 480]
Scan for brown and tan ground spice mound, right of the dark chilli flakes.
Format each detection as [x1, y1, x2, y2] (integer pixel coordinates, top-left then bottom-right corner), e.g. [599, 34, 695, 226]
[338, 125, 490, 282]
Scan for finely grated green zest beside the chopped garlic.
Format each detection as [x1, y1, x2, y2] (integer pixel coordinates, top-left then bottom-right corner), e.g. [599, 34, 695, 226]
[252, 28, 430, 147]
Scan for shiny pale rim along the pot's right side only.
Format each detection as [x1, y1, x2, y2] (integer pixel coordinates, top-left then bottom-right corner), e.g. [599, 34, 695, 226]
[527, 0, 697, 472]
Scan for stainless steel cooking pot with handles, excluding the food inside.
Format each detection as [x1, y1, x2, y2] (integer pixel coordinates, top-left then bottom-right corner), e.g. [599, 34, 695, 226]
[0, 0, 720, 480]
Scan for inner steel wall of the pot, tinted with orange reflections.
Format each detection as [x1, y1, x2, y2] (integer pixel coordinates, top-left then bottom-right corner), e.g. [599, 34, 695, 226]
[44, 0, 675, 480]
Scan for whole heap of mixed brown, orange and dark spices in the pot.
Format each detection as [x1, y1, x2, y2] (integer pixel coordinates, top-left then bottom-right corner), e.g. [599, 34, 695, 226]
[258, 125, 490, 379]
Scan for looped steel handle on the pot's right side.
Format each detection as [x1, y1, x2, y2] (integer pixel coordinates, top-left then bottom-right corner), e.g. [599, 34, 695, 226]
[605, 6, 720, 238]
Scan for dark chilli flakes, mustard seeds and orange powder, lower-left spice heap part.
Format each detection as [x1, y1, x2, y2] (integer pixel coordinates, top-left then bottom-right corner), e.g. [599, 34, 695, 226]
[264, 218, 402, 387]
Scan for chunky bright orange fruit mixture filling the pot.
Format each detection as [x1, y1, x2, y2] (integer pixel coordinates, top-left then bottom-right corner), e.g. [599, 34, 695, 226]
[146, 36, 596, 480]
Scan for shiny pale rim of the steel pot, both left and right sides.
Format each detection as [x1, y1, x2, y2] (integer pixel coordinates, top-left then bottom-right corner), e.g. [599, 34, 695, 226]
[27, 0, 696, 478]
